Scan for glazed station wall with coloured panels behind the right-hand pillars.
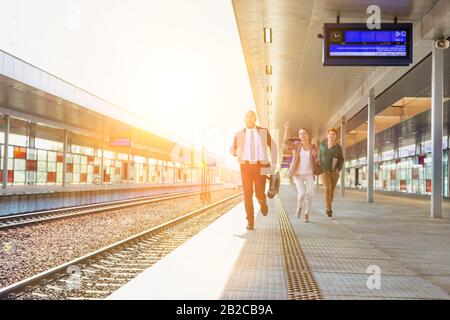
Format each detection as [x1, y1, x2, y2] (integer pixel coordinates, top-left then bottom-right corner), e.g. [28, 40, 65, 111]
[345, 50, 450, 198]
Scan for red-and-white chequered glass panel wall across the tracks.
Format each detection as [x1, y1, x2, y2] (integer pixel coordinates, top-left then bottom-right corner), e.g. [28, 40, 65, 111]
[0, 120, 200, 186]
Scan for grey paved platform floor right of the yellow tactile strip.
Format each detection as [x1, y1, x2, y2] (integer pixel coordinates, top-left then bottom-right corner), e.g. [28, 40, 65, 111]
[280, 185, 450, 299]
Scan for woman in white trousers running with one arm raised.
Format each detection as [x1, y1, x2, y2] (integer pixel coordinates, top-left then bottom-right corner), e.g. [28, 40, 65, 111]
[284, 123, 317, 222]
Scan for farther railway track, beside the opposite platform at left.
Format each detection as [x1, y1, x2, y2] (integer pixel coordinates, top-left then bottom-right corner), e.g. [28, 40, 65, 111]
[0, 189, 229, 230]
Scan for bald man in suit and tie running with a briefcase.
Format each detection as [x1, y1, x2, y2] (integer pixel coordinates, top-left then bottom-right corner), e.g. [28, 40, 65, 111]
[230, 111, 278, 230]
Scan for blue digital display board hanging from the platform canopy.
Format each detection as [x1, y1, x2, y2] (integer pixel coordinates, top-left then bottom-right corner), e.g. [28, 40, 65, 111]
[323, 23, 412, 66]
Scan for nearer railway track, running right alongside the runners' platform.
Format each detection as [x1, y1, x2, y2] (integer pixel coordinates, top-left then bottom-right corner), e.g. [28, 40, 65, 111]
[0, 192, 242, 300]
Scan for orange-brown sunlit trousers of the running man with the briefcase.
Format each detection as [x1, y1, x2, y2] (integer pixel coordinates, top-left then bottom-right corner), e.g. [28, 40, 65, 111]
[241, 164, 266, 225]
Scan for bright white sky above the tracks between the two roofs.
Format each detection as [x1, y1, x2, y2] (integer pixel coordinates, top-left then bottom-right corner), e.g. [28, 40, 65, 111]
[0, 0, 254, 169]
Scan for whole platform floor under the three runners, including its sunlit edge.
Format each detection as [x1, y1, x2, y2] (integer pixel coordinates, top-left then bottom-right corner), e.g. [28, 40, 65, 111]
[108, 185, 450, 300]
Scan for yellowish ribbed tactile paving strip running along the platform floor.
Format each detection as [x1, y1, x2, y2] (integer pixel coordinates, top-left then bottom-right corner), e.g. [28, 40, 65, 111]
[276, 198, 322, 300]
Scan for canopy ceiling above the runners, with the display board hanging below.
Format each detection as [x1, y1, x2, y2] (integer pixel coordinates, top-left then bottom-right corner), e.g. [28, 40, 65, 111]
[233, 0, 450, 137]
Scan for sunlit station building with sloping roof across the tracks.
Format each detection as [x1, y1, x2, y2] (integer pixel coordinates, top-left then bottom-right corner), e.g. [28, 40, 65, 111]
[0, 51, 237, 214]
